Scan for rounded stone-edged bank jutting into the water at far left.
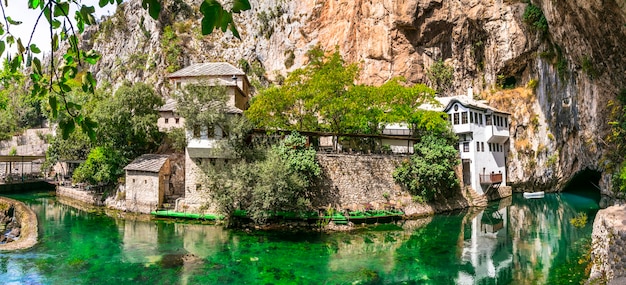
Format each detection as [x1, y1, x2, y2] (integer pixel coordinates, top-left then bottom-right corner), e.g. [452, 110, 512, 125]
[0, 197, 39, 248]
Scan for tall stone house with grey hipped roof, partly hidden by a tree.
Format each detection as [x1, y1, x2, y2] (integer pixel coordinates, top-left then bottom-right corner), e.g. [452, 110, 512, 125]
[168, 62, 250, 212]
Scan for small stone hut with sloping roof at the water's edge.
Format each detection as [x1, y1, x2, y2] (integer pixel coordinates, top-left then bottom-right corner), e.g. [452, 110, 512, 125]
[124, 154, 171, 213]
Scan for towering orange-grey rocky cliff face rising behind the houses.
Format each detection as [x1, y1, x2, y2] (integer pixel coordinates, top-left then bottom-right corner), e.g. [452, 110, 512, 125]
[85, 0, 626, 193]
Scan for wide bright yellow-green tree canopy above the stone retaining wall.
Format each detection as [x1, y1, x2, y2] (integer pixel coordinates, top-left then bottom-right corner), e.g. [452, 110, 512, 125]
[246, 48, 435, 134]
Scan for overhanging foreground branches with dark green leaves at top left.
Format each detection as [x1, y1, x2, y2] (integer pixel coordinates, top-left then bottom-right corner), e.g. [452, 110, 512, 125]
[0, 0, 251, 139]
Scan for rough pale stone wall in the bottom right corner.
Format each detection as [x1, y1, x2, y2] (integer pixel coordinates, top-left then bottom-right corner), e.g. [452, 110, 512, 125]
[589, 205, 626, 284]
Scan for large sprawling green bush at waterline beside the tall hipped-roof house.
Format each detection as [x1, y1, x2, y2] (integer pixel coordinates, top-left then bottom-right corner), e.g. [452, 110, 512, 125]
[204, 133, 321, 223]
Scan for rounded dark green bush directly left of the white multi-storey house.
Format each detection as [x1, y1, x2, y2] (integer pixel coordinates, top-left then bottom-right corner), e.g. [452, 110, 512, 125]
[393, 132, 459, 201]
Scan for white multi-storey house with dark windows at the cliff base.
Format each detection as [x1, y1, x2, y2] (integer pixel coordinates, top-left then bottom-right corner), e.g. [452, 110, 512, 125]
[424, 91, 510, 194]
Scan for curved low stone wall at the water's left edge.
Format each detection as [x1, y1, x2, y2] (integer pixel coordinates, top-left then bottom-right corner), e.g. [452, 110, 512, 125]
[0, 197, 39, 250]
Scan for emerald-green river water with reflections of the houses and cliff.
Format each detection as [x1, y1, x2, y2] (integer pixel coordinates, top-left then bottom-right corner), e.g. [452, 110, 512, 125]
[0, 190, 598, 285]
